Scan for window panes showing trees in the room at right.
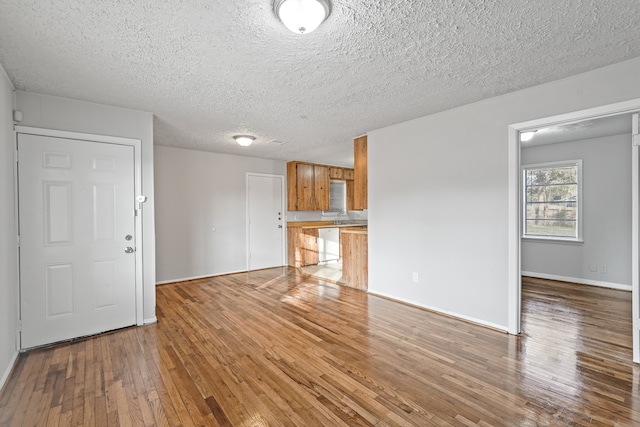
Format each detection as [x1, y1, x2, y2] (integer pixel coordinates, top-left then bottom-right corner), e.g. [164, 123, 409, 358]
[522, 160, 582, 241]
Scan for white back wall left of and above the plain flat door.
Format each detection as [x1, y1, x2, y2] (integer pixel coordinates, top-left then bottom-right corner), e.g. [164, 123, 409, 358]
[155, 146, 286, 283]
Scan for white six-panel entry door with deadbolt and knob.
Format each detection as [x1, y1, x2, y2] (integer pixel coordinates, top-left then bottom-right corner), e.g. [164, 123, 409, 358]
[18, 134, 136, 348]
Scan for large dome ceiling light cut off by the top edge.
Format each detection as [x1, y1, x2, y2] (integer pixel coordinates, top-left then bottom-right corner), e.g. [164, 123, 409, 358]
[273, 0, 331, 34]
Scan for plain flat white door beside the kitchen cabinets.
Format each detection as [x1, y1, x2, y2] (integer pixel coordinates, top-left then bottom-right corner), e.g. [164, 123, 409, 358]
[247, 174, 284, 270]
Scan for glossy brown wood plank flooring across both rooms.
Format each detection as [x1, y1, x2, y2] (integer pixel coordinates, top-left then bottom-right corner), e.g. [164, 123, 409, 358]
[0, 268, 640, 426]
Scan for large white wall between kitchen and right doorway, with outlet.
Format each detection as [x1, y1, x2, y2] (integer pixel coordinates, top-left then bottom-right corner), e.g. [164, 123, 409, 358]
[368, 58, 640, 330]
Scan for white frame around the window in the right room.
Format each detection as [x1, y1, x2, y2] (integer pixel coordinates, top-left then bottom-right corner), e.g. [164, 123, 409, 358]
[520, 159, 584, 243]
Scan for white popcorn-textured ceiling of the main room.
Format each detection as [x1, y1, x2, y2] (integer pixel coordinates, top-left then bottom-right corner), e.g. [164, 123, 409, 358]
[0, 0, 640, 165]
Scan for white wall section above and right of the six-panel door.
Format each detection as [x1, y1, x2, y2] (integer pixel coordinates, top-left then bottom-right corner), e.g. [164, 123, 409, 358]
[16, 91, 156, 323]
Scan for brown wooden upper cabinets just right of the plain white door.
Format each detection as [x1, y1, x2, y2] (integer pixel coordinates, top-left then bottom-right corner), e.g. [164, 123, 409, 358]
[287, 162, 330, 211]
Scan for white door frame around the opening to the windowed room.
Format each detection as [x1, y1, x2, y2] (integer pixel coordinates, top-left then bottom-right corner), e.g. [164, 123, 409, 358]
[507, 98, 640, 363]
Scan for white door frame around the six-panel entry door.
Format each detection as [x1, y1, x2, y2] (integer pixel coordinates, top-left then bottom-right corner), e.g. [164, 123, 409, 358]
[14, 125, 144, 336]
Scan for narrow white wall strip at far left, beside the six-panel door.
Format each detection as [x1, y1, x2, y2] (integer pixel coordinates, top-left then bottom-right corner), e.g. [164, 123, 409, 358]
[0, 66, 18, 388]
